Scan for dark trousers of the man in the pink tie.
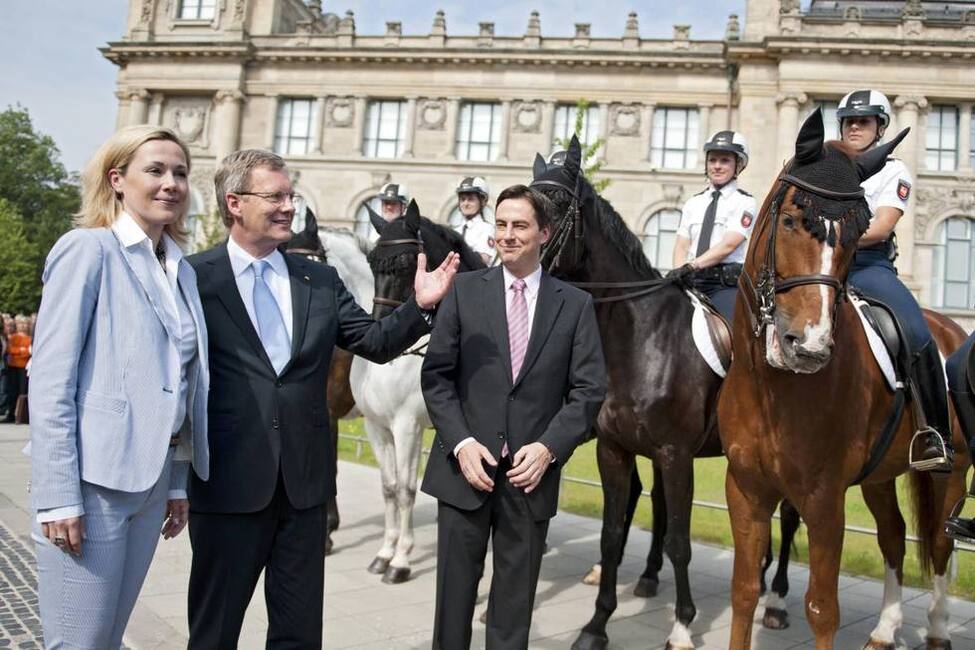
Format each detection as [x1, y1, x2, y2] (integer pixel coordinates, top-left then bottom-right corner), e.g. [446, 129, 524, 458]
[433, 459, 548, 650]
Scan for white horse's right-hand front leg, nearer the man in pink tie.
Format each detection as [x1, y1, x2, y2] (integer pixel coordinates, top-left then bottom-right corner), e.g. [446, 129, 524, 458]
[383, 418, 423, 584]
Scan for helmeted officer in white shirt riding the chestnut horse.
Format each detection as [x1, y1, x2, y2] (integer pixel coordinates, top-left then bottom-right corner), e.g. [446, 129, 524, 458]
[836, 90, 954, 472]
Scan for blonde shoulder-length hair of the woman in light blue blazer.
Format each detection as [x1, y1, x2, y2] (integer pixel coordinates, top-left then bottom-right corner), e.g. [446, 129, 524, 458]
[74, 124, 190, 246]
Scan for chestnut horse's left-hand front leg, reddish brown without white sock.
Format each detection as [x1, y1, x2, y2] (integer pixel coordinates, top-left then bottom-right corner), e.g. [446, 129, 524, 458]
[725, 470, 778, 650]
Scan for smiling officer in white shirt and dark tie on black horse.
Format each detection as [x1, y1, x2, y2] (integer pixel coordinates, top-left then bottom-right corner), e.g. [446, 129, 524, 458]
[669, 131, 757, 323]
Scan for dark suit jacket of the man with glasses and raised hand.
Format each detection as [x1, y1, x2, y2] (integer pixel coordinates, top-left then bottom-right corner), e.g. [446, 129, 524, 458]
[189, 244, 429, 513]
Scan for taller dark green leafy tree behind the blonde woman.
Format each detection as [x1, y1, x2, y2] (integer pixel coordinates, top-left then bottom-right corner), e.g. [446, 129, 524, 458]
[0, 106, 81, 311]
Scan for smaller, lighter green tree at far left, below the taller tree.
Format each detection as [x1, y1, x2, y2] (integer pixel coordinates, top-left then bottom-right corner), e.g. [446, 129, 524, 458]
[0, 198, 41, 313]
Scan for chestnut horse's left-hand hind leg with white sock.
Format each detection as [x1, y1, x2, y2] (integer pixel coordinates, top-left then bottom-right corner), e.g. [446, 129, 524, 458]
[860, 480, 907, 650]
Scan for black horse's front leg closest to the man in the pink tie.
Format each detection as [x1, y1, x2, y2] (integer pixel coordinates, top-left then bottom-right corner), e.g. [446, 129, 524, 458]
[572, 438, 635, 650]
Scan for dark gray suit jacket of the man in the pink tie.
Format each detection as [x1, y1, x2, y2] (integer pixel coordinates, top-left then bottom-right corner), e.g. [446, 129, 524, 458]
[421, 267, 606, 520]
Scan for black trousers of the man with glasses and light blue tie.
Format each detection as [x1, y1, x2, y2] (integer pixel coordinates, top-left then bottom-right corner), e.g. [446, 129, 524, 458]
[188, 476, 326, 650]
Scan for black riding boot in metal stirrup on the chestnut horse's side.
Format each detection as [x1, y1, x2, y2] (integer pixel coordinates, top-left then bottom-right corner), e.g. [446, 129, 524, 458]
[910, 341, 955, 472]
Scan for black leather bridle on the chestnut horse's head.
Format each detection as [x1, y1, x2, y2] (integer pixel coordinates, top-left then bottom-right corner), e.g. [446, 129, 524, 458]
[738, 173, 863, 338]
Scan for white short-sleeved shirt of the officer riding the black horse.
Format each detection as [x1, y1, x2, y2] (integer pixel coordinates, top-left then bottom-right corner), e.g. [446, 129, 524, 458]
[677, 181, 758, 264]
